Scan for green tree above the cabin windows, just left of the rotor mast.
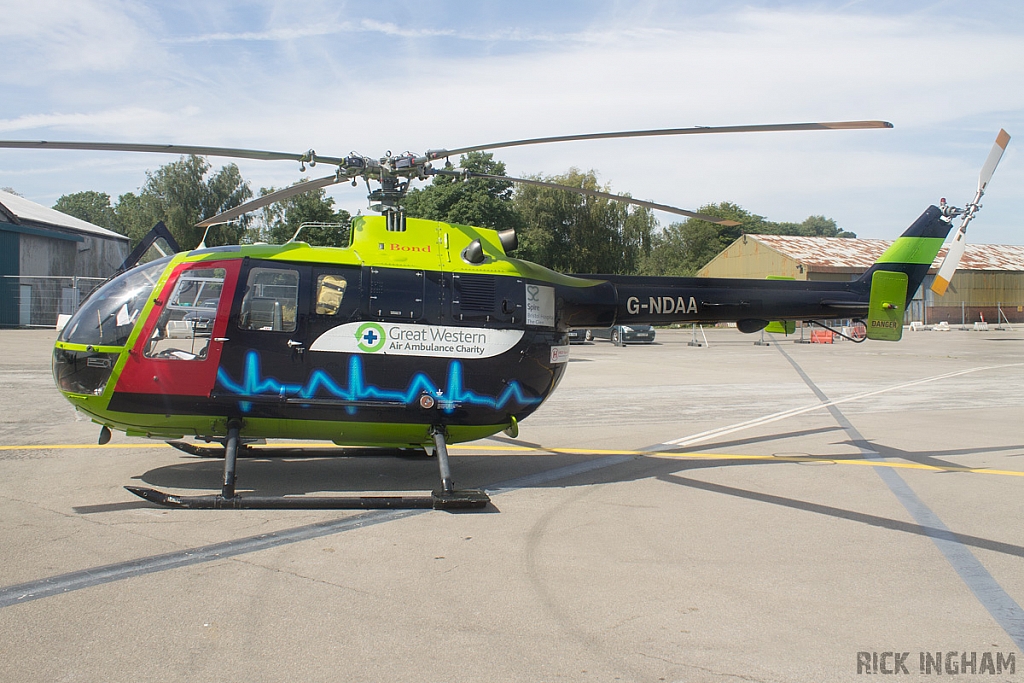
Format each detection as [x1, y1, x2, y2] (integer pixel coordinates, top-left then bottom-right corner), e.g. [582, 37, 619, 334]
[258, 180, 352, 247]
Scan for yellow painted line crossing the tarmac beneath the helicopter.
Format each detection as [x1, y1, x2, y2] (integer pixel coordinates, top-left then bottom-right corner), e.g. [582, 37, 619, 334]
[0, 443, 1024, 477]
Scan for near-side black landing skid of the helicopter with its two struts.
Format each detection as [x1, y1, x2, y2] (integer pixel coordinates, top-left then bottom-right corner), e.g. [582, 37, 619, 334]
[125, 420, 490, 510]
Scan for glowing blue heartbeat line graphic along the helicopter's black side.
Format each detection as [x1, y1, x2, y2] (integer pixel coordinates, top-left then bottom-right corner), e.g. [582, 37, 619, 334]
[217, 351, 541, 414]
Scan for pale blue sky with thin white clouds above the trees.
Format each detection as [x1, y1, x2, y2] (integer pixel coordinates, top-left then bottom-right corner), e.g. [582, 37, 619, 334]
[0, 0, 1024, 245]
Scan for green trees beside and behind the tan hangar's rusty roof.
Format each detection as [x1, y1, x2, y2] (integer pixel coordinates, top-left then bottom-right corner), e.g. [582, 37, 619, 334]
[640, 202, 857, 275]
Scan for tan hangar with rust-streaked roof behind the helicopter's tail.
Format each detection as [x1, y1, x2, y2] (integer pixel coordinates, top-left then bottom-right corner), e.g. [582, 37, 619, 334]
[697, 234, 1024, 325]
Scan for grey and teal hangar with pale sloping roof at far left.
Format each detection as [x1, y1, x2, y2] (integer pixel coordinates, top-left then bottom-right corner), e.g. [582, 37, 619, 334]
[0, 190, 129, 327]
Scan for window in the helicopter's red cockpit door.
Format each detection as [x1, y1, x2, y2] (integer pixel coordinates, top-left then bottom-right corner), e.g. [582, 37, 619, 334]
[144, 268, 224, 360]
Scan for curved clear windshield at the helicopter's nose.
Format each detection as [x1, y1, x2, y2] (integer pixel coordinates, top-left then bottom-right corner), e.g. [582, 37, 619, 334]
[59, 256, 172, 346]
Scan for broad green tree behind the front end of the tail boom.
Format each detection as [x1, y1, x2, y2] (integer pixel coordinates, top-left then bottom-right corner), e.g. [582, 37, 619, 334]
[514, 168, 656, 273]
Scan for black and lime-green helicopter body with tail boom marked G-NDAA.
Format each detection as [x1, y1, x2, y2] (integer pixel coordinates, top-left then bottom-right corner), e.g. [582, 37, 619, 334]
[54, 208, 937, 445]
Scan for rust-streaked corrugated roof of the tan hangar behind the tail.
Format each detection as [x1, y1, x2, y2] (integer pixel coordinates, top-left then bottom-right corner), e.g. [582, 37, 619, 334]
[746, 234, 1024, 272]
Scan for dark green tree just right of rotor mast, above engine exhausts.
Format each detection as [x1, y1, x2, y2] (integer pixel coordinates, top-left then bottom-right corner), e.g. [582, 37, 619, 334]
[402, 152, 520, 230]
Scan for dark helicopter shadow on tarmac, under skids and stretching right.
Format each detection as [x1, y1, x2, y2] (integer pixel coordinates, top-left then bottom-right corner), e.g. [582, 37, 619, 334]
[75, 427, 1024, 558]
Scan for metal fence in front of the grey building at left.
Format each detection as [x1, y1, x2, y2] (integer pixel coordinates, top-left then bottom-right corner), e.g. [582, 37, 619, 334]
[0, 275, 106, 328]
